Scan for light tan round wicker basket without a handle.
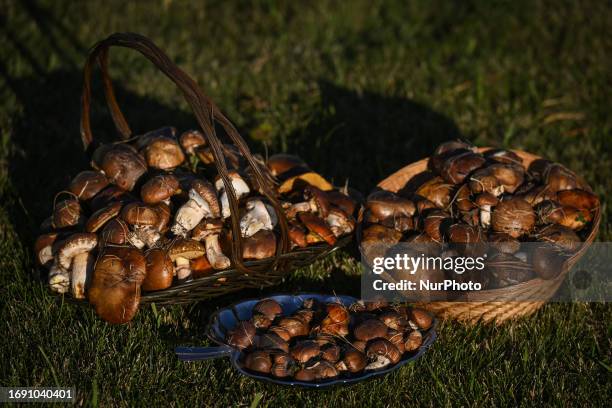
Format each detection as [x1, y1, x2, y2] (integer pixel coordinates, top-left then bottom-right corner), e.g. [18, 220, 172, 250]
[378, 147, 601, 323]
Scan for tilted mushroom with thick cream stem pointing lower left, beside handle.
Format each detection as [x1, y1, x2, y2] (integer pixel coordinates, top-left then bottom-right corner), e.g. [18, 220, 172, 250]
[171, 179, 220, 237]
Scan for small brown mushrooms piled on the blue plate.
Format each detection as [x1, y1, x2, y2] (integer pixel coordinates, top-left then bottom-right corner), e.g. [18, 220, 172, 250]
[226, 299, 432, 382]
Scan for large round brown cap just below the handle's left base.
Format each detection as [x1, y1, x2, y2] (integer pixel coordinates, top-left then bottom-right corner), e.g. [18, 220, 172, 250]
[100, 144, 147, 191]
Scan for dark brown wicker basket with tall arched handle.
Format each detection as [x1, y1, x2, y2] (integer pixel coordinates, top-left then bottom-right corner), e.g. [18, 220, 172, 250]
[58, 33, 351, 304]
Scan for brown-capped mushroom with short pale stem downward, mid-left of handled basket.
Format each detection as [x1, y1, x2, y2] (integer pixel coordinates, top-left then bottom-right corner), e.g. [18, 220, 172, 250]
[121, 202, 161, 249]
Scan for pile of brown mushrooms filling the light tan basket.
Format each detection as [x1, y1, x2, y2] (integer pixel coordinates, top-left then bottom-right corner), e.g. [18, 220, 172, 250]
[362, 141, 599, 289]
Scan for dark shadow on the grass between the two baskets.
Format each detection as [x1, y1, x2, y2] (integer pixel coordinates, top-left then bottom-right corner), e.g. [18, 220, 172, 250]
[288, 81, 461, 195]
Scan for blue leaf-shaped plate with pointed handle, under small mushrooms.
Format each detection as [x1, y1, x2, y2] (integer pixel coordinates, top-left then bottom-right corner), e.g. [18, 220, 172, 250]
[175, 293, 438, 388]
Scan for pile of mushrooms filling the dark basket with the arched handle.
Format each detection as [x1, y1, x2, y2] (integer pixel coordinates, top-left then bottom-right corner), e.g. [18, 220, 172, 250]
[35, 127, 356, 323]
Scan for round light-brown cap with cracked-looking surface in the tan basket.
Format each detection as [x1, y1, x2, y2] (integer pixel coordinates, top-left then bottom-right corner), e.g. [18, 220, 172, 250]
[491, 197, 536, 238]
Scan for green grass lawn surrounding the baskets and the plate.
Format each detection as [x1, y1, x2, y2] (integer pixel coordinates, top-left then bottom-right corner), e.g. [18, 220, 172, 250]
[0, 0, 612, 407]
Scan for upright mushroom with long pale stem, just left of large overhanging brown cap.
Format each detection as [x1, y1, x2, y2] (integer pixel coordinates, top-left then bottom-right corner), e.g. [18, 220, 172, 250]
[57, 233, 98, 299]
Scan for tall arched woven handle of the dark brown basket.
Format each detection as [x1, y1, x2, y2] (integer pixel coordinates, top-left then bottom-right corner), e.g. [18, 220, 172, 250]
[81, 33, 289, 273]
